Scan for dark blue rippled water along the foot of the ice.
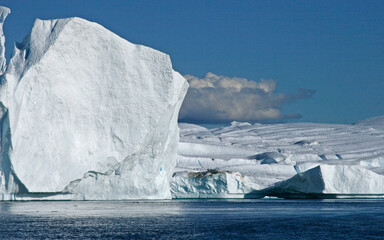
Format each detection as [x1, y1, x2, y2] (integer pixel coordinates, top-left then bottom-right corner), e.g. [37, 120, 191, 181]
[0, 200, 384, 239]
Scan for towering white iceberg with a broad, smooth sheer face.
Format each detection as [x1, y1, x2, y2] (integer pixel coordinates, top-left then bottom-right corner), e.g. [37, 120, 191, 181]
[0, 14, 188, 199]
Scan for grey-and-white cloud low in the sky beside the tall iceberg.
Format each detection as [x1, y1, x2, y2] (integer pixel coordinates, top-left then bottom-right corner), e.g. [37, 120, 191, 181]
[179, 73, 315, 123]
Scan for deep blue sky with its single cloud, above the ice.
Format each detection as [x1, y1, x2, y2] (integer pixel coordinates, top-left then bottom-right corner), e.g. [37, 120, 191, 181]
[1, 0, 384, 123]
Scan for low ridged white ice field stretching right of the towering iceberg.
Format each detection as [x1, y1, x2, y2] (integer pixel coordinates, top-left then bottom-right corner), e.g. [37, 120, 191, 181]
[176, 117, 384, 198]
